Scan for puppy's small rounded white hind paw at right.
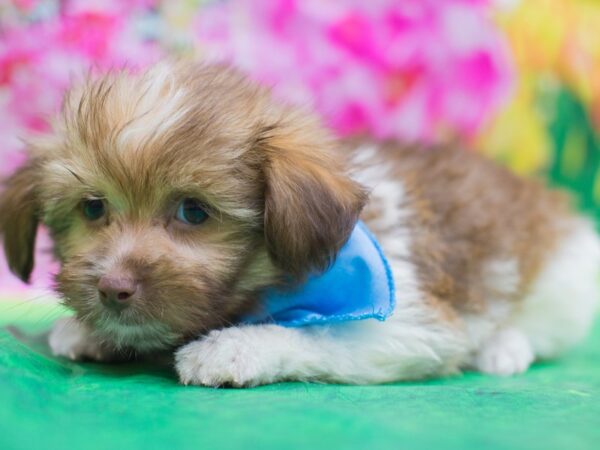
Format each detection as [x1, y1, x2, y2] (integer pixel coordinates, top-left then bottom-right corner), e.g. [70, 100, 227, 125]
[476, 330, 534, 376]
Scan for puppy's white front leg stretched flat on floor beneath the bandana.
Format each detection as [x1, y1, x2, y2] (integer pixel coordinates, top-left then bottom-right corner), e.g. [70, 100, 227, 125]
[176, 308, 467, 386]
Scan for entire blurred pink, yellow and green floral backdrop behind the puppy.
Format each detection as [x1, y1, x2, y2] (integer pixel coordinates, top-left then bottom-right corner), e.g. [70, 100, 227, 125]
[0, 0, 600, 294]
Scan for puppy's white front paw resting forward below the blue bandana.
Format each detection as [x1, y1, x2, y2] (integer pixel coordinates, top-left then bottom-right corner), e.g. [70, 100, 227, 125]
[175, 327, 274, 387]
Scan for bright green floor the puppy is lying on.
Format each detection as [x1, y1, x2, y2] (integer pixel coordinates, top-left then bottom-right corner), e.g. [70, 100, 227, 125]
[0, 302, 600, 450]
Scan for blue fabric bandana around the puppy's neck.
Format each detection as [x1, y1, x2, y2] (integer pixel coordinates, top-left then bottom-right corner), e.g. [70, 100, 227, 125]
[244, 222, 395, 327]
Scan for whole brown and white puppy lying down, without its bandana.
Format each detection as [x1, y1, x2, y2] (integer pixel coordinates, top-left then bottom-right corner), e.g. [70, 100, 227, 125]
[0, 63, 600, 386]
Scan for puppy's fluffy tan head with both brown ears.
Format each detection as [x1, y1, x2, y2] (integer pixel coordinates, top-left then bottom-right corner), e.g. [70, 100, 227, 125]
[0, 64, 366, 351]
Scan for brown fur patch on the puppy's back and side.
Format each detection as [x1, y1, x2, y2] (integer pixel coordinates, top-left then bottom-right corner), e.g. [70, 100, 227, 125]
[358, 144, 569, 311]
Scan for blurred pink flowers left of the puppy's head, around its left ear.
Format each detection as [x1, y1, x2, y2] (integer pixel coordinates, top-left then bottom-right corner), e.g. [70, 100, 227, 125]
[0, 0, 160, 292]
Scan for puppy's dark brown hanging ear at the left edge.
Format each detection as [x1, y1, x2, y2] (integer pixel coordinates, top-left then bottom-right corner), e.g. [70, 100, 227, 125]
[0, 160, 40, 282]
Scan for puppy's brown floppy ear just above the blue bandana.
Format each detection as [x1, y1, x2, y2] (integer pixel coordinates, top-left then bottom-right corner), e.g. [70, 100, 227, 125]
[259, 120, 367, 279]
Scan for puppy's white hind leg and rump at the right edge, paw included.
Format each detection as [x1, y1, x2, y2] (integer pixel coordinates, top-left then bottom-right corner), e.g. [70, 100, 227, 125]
[473, 222, 600, 375]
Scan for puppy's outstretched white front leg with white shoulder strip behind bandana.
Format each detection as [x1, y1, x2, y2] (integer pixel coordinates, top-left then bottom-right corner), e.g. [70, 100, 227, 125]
[176, 179, 469, 386]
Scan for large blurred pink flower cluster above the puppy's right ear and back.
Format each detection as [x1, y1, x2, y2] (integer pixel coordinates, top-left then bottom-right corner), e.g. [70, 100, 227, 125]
[196, 0, 511, 140]
